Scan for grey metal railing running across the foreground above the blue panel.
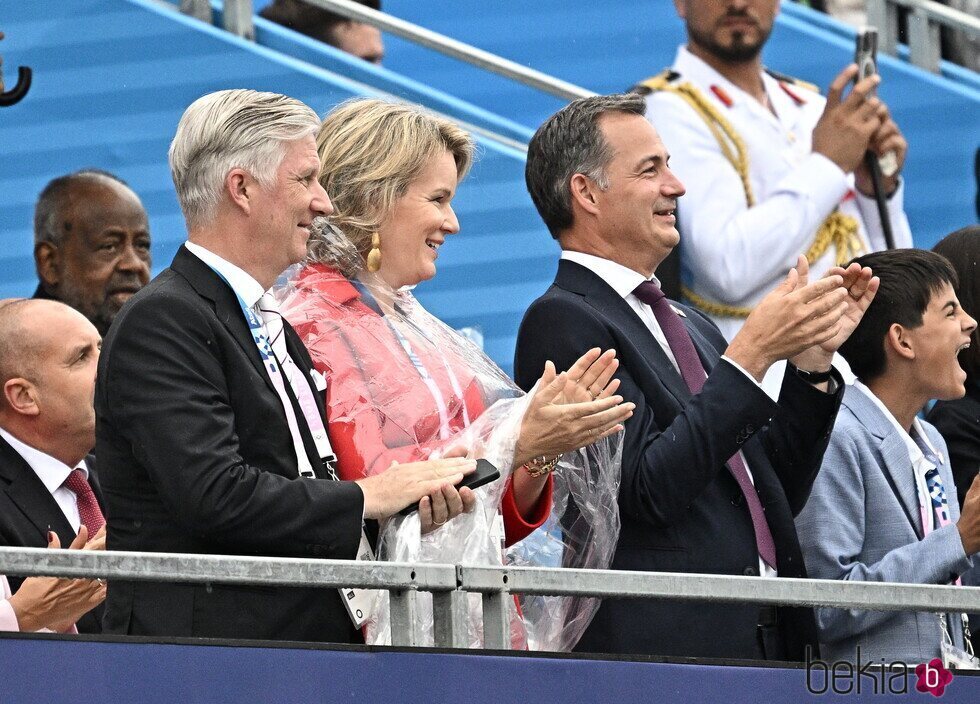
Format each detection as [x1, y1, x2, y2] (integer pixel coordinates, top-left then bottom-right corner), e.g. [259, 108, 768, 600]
[0, 547, 980, 650]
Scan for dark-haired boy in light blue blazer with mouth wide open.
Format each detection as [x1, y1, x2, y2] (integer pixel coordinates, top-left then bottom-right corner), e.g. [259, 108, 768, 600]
[796, 249, 980, 663]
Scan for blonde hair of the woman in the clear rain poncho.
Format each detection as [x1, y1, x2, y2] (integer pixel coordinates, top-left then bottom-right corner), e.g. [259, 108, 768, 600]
[309, 98, 474, 275]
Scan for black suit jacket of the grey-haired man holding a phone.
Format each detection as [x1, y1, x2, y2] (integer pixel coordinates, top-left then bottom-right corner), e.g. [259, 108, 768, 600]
[95, 247, 364, 642]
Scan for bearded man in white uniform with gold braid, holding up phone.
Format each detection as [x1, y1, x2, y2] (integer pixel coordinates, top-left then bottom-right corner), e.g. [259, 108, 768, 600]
[637, 0, 912, 388]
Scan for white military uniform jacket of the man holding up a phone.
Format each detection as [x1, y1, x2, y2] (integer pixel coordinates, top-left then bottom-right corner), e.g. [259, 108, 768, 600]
[646, 47, 912, 340]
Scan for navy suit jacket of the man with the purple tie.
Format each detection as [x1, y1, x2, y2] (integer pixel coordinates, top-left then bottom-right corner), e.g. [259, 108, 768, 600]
[514, 260, 841, 659]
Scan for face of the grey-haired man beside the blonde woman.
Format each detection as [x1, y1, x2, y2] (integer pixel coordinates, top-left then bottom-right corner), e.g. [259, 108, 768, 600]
[250, 135, 333, 280]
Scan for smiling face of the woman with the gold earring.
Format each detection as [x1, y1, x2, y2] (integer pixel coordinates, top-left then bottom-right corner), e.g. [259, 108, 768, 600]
[378, 150, 459, 289]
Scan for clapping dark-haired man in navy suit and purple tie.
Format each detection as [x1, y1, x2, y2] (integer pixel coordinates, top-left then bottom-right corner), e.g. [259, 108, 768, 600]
[515, 95, 876, 660]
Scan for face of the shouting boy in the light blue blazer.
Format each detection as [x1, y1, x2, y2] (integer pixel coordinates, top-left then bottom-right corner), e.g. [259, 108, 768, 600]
[905, 283, 977, 400]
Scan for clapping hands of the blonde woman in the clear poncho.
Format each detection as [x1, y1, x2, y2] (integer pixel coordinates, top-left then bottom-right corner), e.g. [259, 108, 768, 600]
[514, 349, 636, 466]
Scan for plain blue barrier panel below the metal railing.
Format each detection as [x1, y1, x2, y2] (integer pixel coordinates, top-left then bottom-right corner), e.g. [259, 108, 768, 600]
[0, 636, 980, 704]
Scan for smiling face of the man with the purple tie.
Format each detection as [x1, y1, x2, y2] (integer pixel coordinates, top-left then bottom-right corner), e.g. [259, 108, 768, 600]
[595, 112, 684, 275]
